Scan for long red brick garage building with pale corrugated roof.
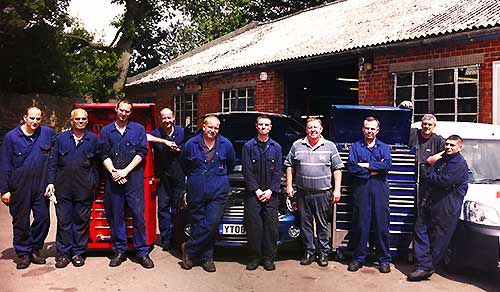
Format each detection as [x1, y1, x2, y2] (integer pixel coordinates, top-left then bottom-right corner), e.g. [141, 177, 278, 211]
[126, 0, 500, 130]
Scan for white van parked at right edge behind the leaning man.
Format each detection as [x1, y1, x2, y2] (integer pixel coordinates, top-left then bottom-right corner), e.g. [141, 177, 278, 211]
[412, 121, 500, 279]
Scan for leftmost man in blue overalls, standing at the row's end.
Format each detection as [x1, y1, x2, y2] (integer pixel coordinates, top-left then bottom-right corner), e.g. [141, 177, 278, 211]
[0, 107, 56, 269]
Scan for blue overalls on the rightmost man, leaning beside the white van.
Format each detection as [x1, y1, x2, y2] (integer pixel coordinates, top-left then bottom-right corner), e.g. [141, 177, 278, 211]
[414, 153, 468, 271]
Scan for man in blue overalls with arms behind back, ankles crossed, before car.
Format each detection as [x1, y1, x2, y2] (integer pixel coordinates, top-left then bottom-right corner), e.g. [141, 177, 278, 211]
[180, 116, 236, 272]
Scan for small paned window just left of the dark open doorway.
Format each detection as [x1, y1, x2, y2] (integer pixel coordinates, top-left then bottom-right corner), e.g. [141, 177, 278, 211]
[221, 87, 255, 112]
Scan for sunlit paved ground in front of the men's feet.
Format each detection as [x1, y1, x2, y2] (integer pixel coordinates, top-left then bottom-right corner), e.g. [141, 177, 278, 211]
[0, 205, 500, 292]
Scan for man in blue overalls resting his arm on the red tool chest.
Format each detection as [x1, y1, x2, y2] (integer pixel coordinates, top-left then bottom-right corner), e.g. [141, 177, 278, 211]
[147, 108, 186, 251]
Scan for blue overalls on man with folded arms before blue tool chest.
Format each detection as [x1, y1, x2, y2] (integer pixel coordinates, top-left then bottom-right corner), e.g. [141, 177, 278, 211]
[347, 140, 392, 264]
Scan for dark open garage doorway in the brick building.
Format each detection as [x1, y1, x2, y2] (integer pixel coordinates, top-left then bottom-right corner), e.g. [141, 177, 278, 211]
[285, 60, 358, 133]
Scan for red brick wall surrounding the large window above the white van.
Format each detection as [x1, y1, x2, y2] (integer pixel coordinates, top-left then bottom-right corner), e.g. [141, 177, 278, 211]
[359, 39, 500, 123]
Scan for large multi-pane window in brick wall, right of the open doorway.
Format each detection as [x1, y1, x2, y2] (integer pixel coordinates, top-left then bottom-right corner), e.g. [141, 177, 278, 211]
[394, 65, 479, 122]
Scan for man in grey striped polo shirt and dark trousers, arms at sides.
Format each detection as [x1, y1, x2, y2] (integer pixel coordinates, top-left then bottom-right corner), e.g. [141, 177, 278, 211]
[284, 118, 344, 267]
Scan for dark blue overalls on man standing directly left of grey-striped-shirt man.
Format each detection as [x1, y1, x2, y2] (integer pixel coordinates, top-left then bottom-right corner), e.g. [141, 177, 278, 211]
[241, 138, 283, 260]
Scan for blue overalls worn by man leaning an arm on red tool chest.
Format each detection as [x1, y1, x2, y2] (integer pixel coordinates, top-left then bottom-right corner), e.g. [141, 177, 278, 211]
[150, 126, 186, 243]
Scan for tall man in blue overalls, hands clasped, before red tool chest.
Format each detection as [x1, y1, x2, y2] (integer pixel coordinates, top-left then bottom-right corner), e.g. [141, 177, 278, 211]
[98, 100, 154, 269]
